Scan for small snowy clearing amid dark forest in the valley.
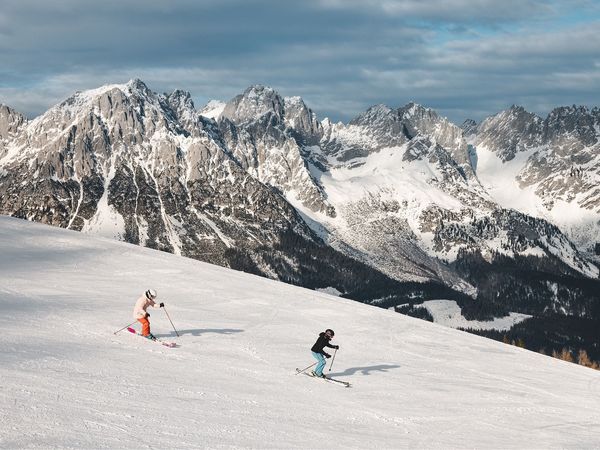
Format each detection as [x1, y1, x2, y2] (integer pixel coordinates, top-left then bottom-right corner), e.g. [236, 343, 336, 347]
[417, 300, 531, 331]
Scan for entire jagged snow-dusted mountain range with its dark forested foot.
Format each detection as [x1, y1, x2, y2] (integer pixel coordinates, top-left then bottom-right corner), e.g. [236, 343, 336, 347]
[0, 80, 600, 357]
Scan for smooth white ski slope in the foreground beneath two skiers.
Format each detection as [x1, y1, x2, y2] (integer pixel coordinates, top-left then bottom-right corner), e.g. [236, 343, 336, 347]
[0, 217, 600, 449]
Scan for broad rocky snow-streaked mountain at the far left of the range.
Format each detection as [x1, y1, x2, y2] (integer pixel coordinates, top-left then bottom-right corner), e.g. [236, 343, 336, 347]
[0, 80, 312, 264]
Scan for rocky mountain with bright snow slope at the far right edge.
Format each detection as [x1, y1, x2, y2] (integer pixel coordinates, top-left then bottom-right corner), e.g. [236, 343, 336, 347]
[469, 106, 600, 260]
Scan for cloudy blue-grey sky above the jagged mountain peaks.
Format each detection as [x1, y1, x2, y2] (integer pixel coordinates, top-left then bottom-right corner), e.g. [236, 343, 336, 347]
[0, 0, 600, 123]
